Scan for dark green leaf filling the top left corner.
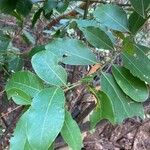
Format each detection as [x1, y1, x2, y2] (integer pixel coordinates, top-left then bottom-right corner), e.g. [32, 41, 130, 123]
[0, 0, 17, 14]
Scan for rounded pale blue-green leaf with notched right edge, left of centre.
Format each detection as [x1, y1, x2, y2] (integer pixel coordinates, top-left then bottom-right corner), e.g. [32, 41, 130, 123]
[31, 49, 67, 86]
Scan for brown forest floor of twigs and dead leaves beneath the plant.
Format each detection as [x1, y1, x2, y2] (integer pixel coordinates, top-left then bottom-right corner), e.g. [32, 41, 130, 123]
[0, 10, 150, 150]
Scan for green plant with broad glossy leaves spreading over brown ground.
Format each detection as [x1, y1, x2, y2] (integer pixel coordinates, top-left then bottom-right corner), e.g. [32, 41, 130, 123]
[0, 0, 150, 150]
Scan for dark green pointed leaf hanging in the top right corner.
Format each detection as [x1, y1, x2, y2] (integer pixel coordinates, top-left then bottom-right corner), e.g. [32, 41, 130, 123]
[130, 0, 150, 18]
